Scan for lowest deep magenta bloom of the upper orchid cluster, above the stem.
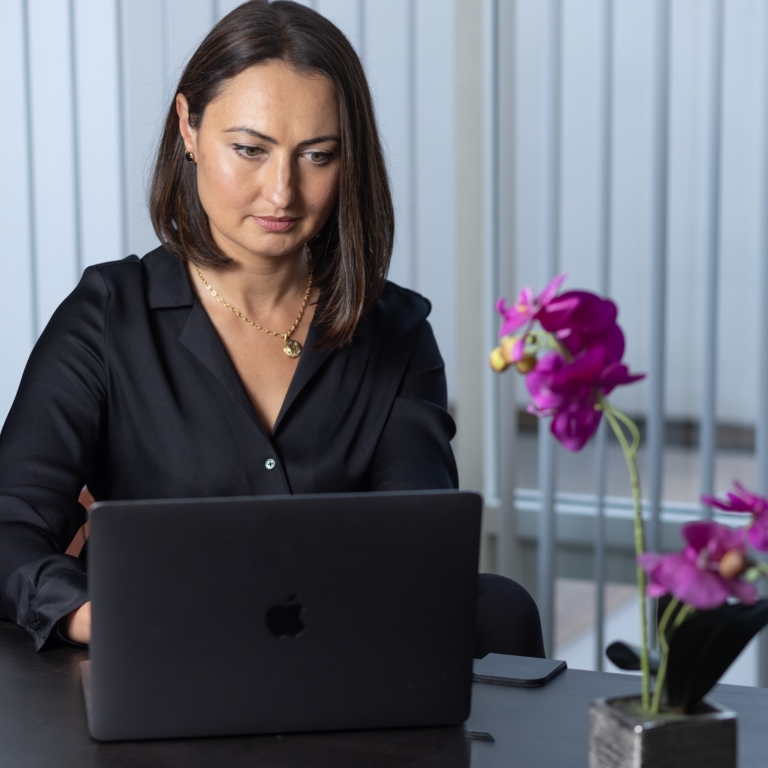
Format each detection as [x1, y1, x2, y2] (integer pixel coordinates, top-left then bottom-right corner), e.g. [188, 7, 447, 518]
[525, 345, 644, 451]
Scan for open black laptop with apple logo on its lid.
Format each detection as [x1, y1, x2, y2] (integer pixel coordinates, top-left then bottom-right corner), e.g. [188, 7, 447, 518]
[82, 491, 482, 741]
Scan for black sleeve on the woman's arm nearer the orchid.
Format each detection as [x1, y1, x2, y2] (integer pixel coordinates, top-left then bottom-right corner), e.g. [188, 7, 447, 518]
[371, 320, 459, 491]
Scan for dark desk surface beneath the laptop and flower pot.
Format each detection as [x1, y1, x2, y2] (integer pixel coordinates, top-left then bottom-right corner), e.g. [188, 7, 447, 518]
[0, 622, 768, 768]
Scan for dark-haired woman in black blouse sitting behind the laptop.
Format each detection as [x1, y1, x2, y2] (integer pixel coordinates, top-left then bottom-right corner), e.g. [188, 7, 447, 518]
[0, 0, 541, 655]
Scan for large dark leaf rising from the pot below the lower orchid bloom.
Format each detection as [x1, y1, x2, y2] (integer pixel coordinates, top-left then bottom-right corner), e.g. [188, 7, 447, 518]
[666, 600, 768, 713]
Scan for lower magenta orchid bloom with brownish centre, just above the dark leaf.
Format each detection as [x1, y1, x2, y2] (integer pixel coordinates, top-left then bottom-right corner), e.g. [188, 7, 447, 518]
[638, 520, 757, 610]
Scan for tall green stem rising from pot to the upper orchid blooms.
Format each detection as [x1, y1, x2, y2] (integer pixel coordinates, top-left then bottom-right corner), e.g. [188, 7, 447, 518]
[598, 397, 651, 710]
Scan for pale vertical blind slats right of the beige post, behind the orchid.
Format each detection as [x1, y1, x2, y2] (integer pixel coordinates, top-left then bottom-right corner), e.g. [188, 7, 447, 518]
[496, 0, 768, 666]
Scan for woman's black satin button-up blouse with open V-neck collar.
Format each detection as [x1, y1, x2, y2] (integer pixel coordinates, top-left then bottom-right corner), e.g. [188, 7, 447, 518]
[0, 248, 458, 649]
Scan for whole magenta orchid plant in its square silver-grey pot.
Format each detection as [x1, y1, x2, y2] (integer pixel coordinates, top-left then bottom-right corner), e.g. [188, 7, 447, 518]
[490, 275, 768, 768]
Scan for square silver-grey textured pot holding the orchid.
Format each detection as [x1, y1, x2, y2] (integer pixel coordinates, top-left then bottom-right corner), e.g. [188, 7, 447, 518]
[589, 696, 736, 768]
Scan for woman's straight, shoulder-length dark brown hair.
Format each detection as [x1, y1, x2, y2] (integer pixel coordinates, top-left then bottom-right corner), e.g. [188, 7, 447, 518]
[149, 0, 394, 347]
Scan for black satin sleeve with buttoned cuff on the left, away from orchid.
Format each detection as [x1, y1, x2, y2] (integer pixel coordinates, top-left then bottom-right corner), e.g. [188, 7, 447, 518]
[0, 268, 109, 650]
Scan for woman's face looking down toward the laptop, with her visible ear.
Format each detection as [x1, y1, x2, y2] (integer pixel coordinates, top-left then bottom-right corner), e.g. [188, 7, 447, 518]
[176, 61, 340, 263]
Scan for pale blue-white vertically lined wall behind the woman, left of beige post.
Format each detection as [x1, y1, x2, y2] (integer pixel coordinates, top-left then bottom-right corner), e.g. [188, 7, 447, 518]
[0, 0, 456, 422]
